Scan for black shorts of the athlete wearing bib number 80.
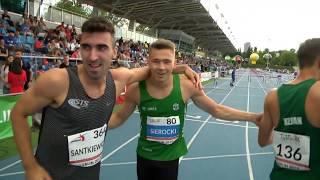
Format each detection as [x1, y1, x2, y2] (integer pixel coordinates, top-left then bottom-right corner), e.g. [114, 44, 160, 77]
[137, 155, 179, 180]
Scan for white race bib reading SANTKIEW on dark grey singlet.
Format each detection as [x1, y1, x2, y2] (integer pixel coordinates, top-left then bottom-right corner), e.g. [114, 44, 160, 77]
[68, 124, 107, 167]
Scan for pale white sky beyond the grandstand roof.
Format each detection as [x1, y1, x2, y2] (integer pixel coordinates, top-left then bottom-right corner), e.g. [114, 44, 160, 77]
[201, 0, 320, 50]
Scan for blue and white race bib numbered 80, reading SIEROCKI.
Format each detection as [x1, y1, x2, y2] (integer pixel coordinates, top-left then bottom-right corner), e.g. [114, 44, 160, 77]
[146, 116, 180, 145]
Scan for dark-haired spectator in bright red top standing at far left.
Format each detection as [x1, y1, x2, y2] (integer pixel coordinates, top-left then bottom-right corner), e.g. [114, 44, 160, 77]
[7, 59, 27, 93]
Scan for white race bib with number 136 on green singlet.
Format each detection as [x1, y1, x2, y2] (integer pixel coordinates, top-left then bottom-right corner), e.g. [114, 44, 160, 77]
[273, 131, 310, 171]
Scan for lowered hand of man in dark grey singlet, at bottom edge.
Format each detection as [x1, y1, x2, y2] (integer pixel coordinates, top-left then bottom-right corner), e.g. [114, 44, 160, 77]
[26, 165, 52, 180]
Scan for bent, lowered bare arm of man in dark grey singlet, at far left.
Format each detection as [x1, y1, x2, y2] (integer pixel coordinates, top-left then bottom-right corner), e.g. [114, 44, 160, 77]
[11, 70, 65, 178]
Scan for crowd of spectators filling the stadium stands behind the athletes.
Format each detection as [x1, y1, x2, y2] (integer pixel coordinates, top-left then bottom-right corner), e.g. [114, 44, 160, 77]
[0, 10, 229, 94]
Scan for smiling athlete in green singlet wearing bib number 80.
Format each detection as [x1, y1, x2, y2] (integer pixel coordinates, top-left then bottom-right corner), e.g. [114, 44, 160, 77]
[108, 39, 260, 180]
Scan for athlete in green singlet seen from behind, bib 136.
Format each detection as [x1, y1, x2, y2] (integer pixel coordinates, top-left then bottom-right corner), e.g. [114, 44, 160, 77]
[259, 38, 320, 180]
